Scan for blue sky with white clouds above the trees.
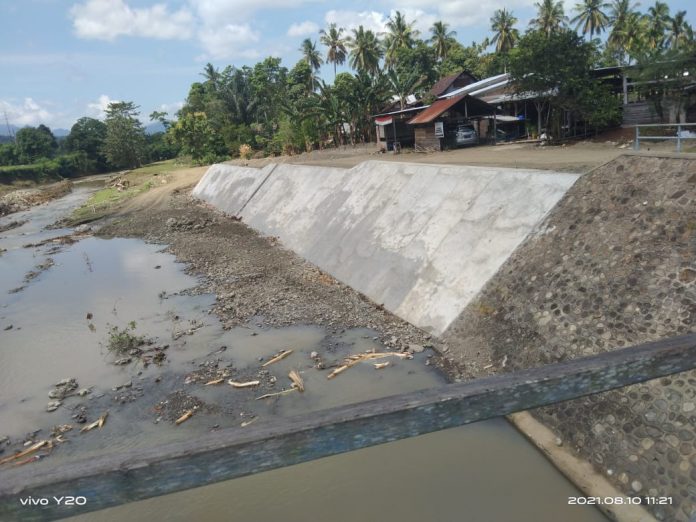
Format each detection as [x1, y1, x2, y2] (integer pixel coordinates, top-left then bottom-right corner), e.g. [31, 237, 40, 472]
[0, 0, 696, 129]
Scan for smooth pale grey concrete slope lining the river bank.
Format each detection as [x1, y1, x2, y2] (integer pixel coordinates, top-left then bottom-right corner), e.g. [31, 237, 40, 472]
[194, 161, 577, 334]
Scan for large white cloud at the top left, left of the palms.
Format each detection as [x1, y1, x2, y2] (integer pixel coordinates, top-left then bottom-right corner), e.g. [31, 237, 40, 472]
[70, 0, 195, 40]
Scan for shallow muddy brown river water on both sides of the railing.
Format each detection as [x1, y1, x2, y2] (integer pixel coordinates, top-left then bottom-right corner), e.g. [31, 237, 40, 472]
[0, 184, 605, 522]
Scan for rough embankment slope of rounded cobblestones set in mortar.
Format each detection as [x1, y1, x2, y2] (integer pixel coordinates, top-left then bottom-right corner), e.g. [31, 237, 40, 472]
[443, 156, 696, 521]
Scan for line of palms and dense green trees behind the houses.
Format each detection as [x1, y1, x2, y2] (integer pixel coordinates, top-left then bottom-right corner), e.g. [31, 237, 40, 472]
[0, 0, 696, 175]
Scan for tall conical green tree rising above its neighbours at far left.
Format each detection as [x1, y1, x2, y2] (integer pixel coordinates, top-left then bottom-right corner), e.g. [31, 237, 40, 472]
[104, 102, 145, 168]
